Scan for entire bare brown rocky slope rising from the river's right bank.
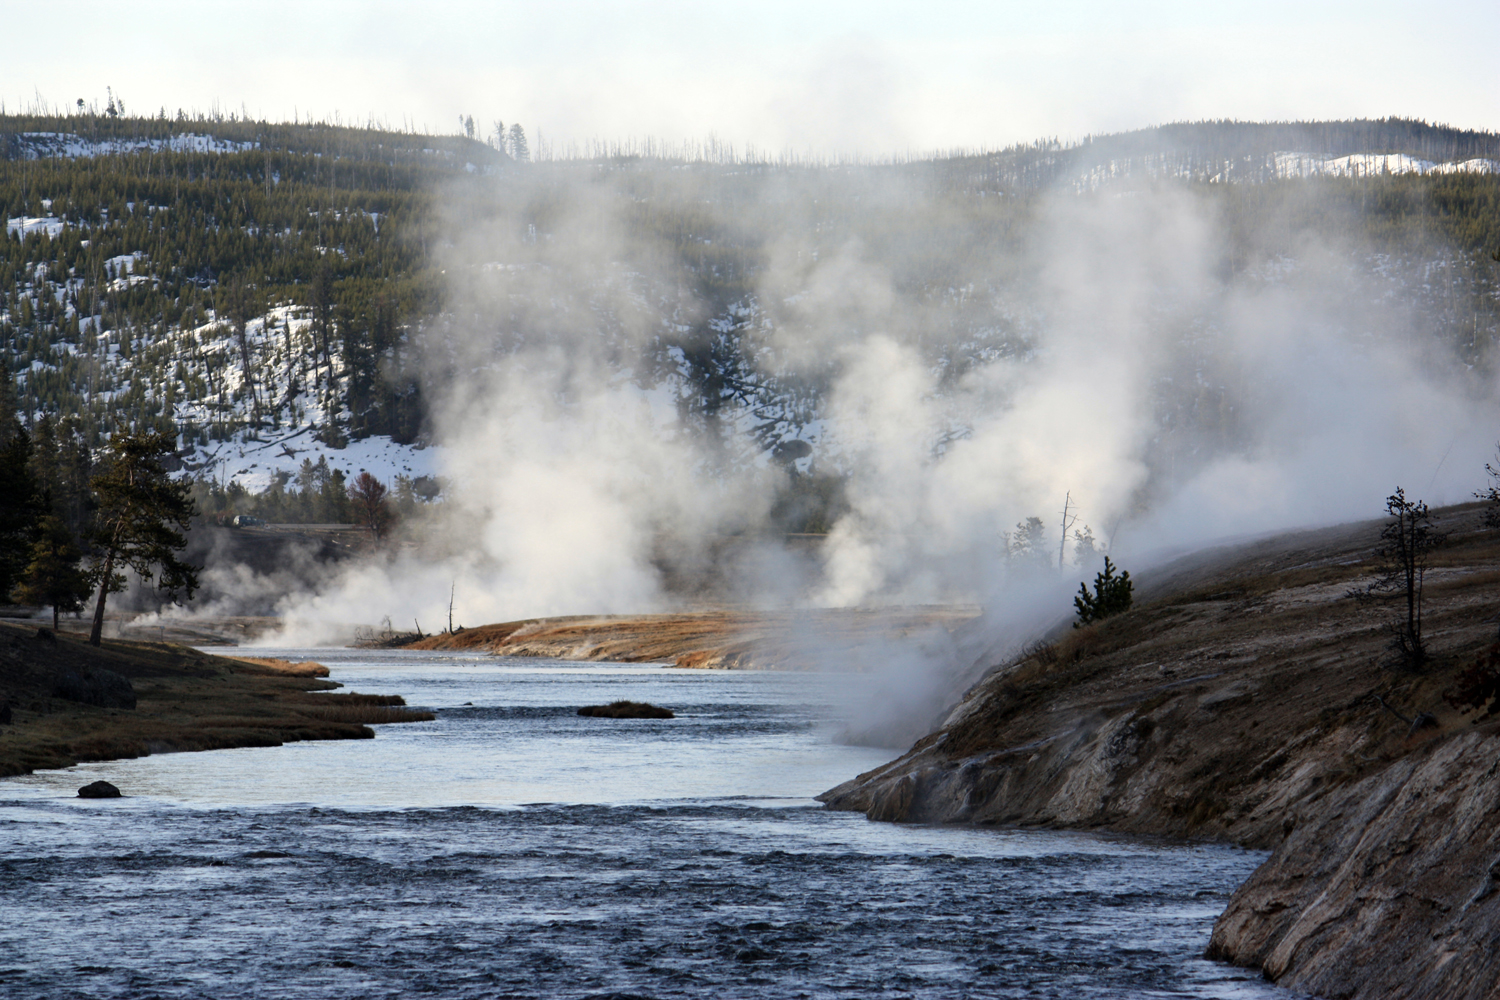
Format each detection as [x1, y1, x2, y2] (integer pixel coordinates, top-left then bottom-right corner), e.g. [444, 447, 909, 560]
[822, 505, 1500, 997]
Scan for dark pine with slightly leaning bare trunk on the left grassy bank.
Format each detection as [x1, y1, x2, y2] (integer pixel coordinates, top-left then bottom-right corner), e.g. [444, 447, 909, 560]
[89, 433, 198, 646]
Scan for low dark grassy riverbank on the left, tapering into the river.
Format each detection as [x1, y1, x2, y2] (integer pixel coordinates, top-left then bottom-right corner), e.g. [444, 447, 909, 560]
[0, 624, 432, 777]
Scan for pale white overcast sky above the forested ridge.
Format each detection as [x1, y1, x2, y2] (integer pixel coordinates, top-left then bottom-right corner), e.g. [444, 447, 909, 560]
[11, 0, 1500, 154]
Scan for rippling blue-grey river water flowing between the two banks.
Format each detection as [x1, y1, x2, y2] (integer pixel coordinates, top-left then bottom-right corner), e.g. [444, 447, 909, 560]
[0, 648, 1292, 1000]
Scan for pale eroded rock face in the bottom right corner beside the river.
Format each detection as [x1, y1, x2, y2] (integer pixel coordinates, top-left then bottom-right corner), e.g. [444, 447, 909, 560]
[1209, 733, 1500, 1000]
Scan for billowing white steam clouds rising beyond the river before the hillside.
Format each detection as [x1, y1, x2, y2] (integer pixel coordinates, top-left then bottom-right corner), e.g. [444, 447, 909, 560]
[217, 162, 1500, 728]
